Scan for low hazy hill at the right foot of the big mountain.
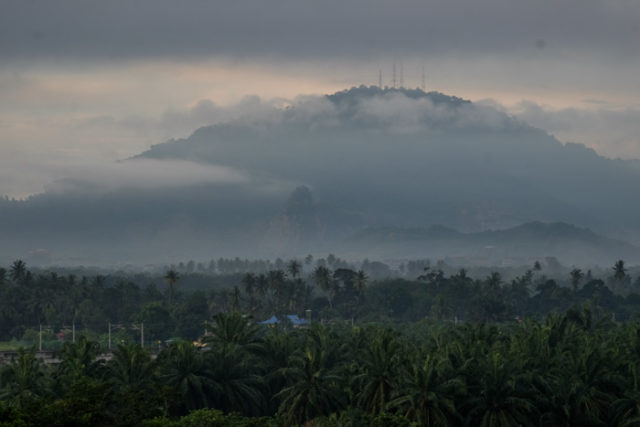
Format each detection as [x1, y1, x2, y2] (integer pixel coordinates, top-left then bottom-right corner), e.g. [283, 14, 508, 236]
[345, 222, 640, 265]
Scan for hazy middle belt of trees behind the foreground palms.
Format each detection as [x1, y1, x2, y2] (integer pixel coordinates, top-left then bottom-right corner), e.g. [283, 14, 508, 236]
[0, 260, 640, 348]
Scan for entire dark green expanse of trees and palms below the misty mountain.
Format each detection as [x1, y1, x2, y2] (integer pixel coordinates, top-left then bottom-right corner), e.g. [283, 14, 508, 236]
[0, 259, 640, 426]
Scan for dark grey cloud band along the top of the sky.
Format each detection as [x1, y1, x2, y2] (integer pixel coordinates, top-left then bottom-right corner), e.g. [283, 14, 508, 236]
[0, 0, 640, 59]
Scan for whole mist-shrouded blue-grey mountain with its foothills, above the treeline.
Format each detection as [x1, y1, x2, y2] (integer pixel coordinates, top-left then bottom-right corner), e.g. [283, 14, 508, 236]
[0, 86, 640, 264]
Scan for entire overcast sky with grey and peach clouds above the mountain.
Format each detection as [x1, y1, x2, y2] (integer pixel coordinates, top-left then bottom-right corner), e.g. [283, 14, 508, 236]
[0, 0, 640, 196]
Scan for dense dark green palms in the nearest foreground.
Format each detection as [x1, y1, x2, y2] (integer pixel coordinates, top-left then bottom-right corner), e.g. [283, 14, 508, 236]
[0, 308, 640, 427]
